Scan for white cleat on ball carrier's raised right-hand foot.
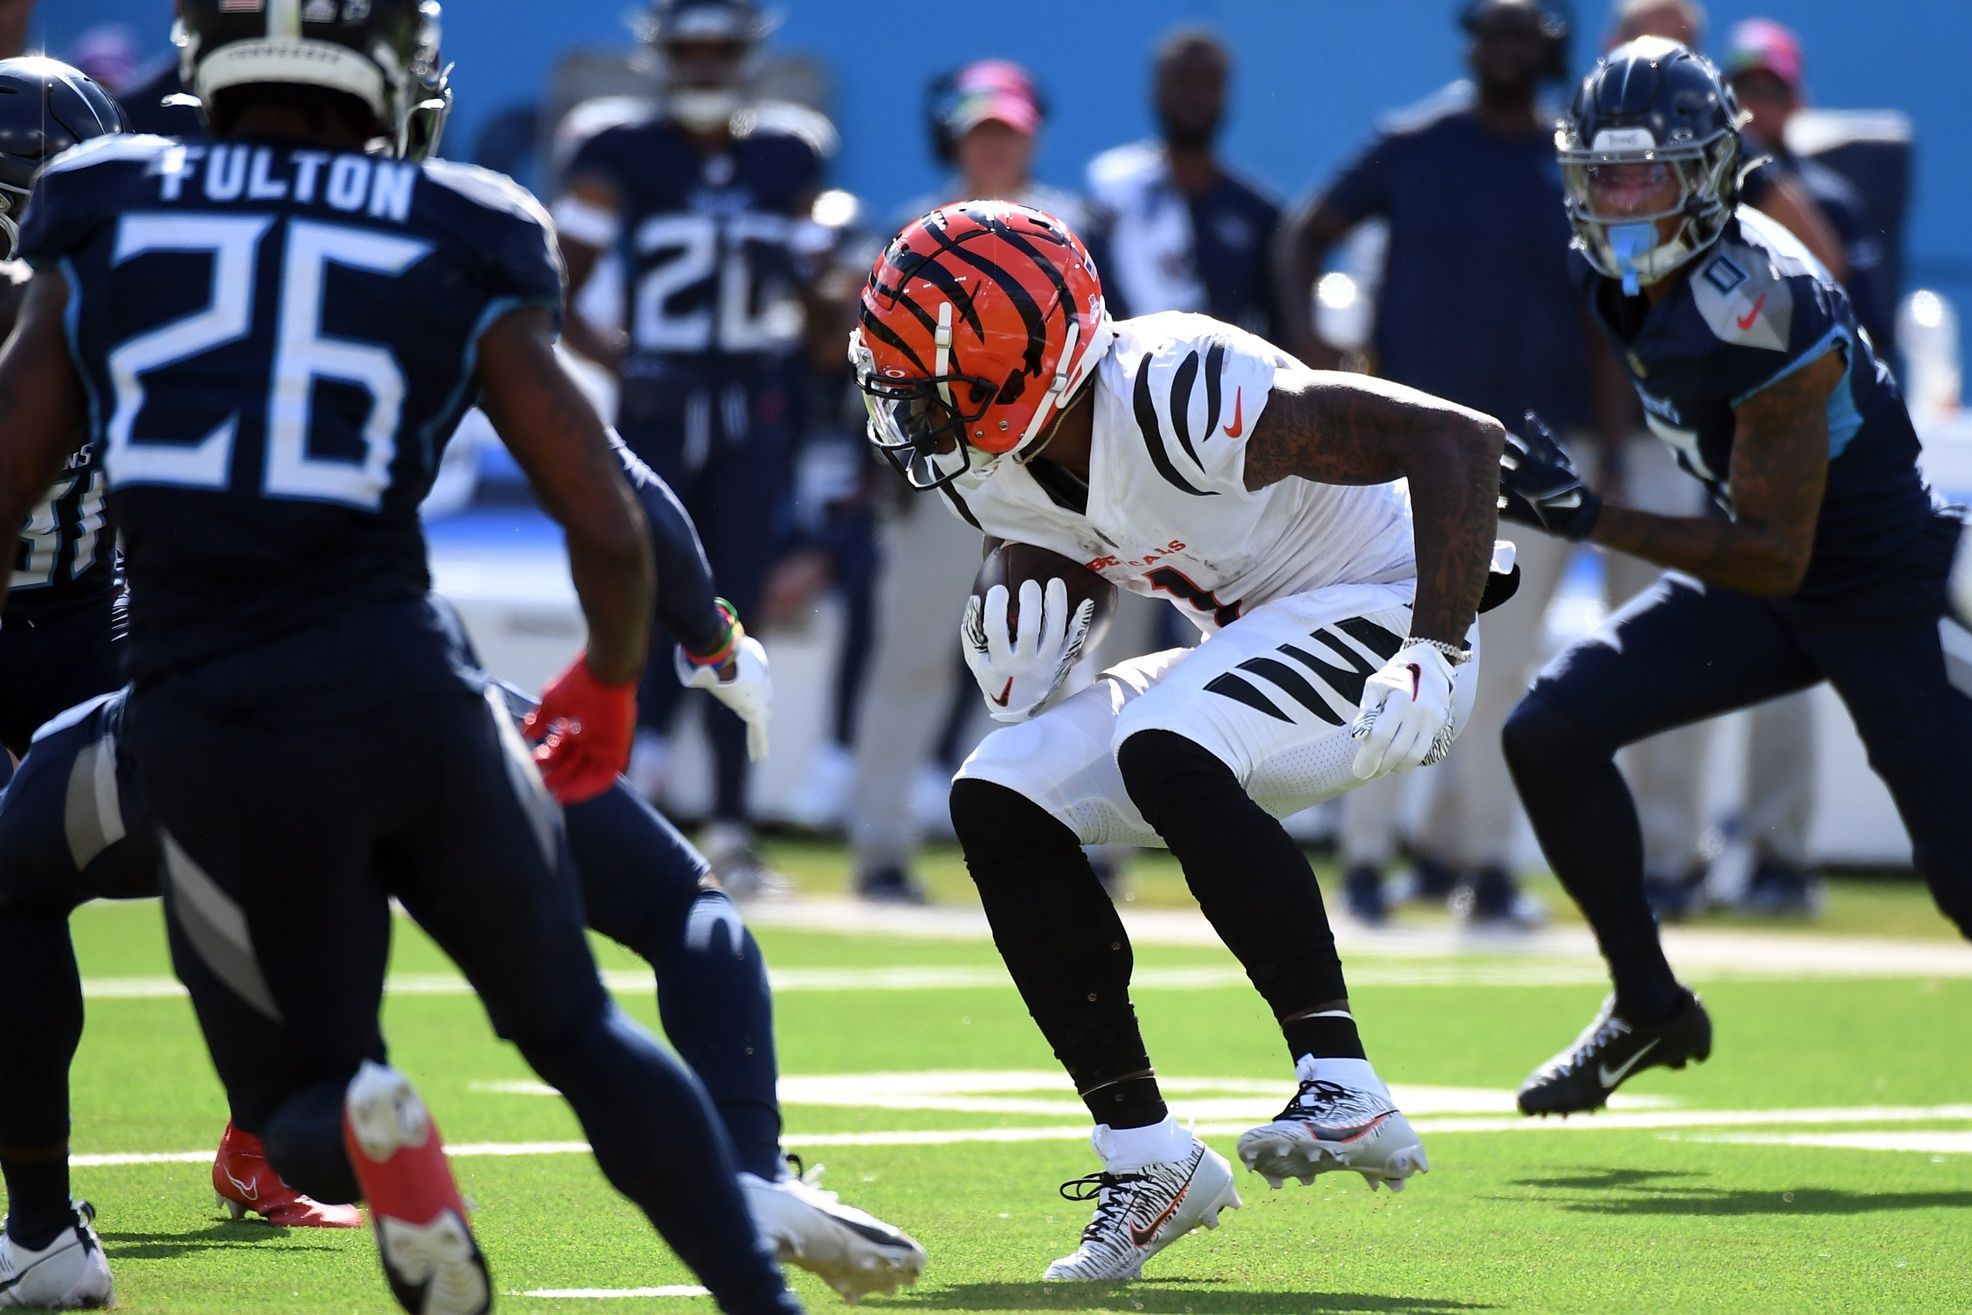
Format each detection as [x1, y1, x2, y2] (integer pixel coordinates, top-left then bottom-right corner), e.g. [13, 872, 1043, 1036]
[1238, 1055, 1432, 1191]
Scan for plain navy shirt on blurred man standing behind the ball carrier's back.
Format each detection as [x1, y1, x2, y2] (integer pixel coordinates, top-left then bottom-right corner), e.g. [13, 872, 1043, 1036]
[1321, 87, 1591, 434]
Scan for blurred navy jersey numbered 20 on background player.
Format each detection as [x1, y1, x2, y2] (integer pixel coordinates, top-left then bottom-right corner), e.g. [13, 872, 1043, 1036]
[564, 103, 834, 386]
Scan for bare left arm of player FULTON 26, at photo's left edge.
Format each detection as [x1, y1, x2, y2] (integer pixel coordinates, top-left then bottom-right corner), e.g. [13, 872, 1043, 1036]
[0, 270, 89, 615]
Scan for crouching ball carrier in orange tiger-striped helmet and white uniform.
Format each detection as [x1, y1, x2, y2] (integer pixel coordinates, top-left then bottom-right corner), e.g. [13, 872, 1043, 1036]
[850, 201, 1503, 1280]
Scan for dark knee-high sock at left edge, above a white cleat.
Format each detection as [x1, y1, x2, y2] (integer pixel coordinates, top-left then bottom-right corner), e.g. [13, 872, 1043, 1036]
[0, 910, 83, 1248]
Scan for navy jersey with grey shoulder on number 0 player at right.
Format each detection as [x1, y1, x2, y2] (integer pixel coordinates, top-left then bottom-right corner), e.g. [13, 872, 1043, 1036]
[1576, 207, 1931, 597]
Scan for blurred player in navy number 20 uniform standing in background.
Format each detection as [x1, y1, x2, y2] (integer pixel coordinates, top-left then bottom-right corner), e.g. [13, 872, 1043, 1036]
[554, 0, 834, 897]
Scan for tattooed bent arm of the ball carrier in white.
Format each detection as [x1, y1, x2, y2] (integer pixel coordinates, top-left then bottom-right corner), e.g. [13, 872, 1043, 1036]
[1246, 369, 1507, 645]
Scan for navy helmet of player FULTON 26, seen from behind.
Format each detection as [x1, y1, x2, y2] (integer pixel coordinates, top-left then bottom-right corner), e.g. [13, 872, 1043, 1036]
[174, 0, 444, 156]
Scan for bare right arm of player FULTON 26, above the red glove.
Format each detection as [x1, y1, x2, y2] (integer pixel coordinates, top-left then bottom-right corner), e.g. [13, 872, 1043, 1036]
[479, 308, 655, 684]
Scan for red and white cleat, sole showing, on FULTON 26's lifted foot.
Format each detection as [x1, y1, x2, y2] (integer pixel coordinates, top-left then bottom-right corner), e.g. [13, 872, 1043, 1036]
[343, 1061, 493, 1315]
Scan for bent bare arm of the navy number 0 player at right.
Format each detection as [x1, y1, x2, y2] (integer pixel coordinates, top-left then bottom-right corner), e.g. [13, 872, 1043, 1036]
[1589, 351, 1846, 597]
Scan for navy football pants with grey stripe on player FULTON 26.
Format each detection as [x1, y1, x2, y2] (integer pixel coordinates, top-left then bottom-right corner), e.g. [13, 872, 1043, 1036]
[126, 682, 799, 1311]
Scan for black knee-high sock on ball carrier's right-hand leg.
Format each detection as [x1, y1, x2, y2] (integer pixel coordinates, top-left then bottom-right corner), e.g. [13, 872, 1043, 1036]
[1116, 731, 1363, 1059]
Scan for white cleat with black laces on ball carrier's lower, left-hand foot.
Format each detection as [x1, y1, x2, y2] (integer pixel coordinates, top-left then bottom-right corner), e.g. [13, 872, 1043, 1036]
[1041, 1126, 1242, 1281]
